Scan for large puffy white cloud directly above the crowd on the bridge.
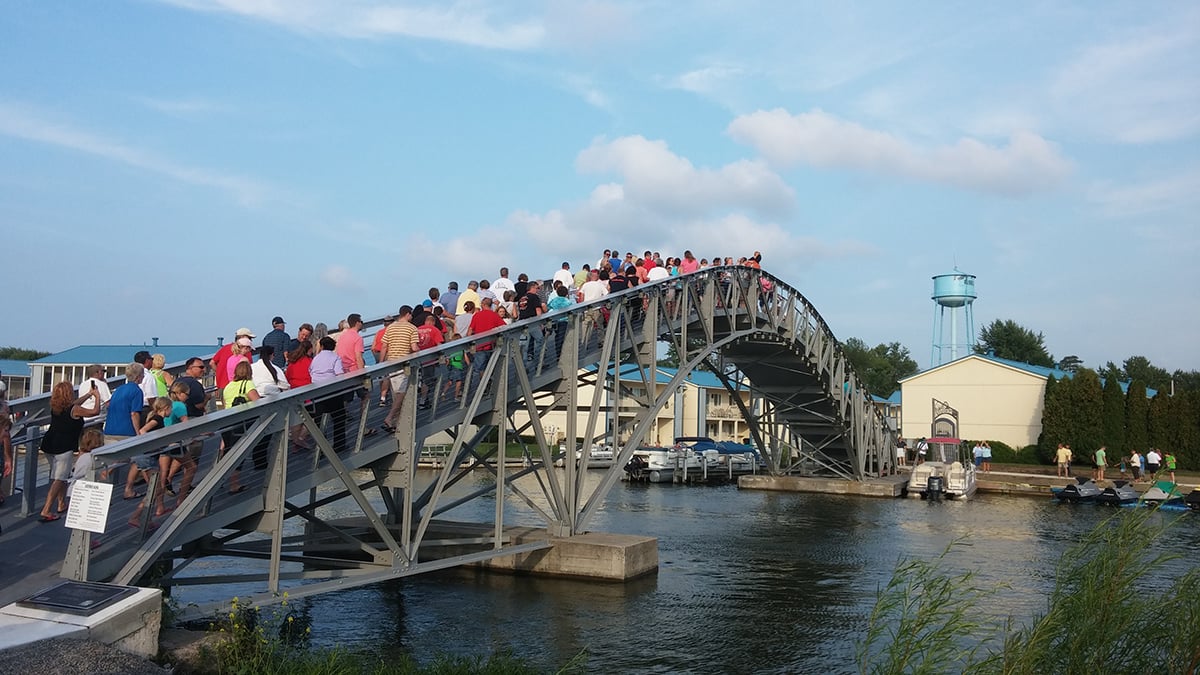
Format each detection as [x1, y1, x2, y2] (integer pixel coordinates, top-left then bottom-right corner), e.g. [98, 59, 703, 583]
[427, 136, 877, 279]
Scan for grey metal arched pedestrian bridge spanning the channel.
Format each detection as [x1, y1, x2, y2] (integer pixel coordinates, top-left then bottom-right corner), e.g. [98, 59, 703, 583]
[7, 267, 894, 615]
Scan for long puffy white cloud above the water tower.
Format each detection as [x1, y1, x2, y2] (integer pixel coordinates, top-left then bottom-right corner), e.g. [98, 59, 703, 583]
[728, 108, 1072, 195]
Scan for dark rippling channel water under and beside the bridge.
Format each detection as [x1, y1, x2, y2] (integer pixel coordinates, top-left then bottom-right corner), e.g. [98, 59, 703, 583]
[174, 476, 1200, 673]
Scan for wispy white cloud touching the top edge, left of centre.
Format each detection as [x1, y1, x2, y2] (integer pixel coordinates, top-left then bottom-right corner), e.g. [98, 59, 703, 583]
[160, 0, 546, 50]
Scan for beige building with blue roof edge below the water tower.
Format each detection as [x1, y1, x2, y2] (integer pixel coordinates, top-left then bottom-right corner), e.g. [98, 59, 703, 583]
[900, 354, 1068, 449]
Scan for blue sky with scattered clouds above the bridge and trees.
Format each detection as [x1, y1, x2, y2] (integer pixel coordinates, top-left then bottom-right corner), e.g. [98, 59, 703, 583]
[0, 0, 1200, 370]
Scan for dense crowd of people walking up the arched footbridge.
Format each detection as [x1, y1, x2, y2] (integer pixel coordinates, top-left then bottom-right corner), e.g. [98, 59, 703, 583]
[28, 249, 769, 526]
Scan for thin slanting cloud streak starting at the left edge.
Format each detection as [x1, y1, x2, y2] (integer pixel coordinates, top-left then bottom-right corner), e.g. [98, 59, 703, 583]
[0, 102, 270, 204]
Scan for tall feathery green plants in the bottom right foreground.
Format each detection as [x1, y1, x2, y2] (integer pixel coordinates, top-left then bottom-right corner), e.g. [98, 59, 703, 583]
[856, 509, 1200, 675]
